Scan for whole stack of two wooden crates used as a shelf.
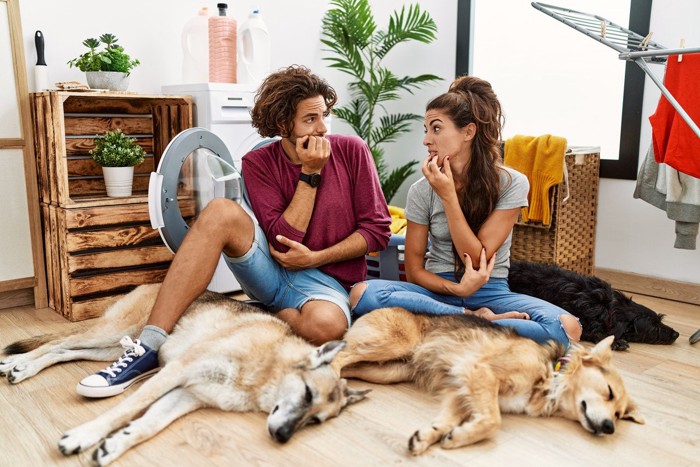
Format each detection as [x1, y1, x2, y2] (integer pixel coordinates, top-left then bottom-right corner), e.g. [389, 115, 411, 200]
[30, 91, 194, 321]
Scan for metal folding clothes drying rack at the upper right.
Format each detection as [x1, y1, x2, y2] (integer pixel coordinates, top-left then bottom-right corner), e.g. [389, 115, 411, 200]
[532, 2, 700, 138]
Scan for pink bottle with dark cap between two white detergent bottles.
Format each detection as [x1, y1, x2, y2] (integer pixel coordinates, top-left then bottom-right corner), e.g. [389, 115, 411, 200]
[209, 3, 238, 83]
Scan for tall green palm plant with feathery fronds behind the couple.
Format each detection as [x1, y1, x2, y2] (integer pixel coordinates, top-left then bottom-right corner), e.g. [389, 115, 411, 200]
[321, 0, 441, 202]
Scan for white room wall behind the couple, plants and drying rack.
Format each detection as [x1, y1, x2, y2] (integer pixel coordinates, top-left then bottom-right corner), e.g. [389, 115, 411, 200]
[20, 0, 700, 283]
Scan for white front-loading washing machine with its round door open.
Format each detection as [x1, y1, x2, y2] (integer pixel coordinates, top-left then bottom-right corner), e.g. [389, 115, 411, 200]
[148, 83, 271, 293]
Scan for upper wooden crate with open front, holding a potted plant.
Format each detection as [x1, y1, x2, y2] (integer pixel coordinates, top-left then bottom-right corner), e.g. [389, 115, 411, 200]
[31, 91, 192, 207]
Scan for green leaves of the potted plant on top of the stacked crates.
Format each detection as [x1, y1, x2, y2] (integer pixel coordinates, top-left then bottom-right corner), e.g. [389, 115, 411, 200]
[68, 34, 141, 74]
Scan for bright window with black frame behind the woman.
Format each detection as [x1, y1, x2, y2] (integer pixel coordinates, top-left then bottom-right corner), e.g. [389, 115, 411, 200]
[456, 0, 651, 180]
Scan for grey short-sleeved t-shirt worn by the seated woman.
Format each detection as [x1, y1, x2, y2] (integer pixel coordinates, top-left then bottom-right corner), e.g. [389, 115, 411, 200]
[405, 167, 530, 277]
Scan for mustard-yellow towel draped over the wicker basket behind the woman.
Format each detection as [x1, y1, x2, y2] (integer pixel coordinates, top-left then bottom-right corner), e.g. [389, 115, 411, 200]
[503, 135, 567, 225]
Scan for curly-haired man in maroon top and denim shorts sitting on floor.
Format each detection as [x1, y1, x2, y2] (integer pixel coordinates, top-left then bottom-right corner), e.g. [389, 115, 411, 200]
[77, 66, 391, 397]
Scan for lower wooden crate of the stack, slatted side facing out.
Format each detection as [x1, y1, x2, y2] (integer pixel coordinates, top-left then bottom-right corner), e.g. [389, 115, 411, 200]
[42, 203, 173, 321]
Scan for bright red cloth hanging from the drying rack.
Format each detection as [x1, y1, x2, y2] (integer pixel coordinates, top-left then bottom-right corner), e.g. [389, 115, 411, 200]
[649, 54, 700, 178]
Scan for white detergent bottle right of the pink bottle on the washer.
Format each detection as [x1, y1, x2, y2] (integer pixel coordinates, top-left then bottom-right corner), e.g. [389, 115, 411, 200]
[238, 10, 272, 85]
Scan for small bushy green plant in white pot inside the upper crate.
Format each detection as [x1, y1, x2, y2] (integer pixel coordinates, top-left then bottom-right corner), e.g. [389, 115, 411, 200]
[90, 129, 146, 198]
